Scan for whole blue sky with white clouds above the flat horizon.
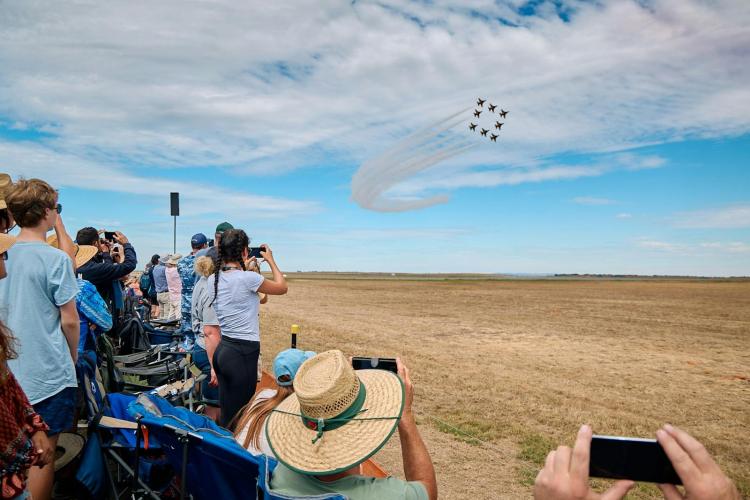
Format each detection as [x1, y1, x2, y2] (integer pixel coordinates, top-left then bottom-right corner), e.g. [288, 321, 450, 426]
[0, 0, 750, 276]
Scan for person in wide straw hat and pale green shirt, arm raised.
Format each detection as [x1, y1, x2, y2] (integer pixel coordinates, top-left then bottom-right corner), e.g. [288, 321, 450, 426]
[266, 351, 437, 500]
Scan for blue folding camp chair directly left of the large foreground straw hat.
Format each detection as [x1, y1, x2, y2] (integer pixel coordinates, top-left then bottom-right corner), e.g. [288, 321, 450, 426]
[128, 394, 266, 500]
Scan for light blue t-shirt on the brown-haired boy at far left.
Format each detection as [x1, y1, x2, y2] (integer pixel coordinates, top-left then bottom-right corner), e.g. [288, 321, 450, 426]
[0, 241, 78, 404]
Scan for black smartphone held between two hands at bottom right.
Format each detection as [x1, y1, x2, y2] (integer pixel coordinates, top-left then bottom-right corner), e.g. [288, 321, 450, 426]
[589, 435, 682, 484]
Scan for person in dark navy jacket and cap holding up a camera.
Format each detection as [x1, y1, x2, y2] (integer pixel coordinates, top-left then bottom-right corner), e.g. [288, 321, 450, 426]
[76, 227, 138, 307]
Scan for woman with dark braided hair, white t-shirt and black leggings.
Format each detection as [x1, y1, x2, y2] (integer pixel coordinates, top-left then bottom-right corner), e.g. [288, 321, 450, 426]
[207, 229, 287, 427]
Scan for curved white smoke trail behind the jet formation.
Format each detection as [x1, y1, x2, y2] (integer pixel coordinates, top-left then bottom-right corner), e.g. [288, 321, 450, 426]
[352, 107, 477, 212]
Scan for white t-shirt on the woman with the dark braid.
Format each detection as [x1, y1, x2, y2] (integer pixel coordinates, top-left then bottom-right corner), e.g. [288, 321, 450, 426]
[206, 270, 265, 342]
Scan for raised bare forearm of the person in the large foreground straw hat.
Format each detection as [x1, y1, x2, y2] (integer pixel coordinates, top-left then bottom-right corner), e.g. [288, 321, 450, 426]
[397, 359, 437, 500]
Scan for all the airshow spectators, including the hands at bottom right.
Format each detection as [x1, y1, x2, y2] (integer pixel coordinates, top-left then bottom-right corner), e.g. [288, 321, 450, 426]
[0, 174, 739, 500]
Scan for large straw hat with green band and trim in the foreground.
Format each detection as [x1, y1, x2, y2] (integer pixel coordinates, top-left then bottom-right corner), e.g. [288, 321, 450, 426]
[266, 351, 404, 476]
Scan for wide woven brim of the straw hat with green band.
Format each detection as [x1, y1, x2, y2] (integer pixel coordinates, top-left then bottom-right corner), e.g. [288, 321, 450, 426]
[266, 370, 404, 476]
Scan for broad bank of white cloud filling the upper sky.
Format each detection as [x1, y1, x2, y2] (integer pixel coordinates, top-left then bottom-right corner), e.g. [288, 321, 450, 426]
[0, 0, 750, 207]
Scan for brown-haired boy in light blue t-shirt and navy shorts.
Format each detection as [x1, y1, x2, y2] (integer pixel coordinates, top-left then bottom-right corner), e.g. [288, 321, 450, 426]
[0, 179, 80, 500]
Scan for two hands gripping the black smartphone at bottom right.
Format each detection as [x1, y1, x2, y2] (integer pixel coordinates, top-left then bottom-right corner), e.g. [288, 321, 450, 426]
[534, 425, 740, 500]
